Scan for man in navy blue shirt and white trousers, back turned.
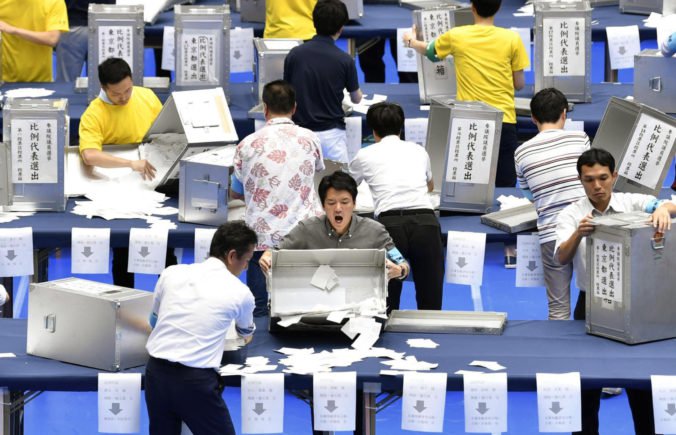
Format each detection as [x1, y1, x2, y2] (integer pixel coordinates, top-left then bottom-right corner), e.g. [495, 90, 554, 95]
[284, 0, 362, 162]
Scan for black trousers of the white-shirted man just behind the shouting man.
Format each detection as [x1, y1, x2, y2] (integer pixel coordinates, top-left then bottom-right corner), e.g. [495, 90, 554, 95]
[378, 209, 444, 312]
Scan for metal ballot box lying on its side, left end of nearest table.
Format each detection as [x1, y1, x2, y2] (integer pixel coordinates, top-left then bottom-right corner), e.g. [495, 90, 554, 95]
[26, 278, 153, 371]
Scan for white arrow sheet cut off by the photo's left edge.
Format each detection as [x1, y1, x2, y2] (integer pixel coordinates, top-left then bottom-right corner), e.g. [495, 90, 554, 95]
[0, 227, 33, 277]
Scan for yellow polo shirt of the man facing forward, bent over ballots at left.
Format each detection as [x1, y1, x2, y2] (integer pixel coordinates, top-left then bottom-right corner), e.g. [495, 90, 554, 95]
[80, 86, 162, 153]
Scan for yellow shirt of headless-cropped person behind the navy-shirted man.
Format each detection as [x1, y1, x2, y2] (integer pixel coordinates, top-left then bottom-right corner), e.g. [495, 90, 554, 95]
[263, 0, 317, 40]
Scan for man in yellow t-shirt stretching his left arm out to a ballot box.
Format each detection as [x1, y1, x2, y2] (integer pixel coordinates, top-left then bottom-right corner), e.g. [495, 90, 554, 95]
[403, 0, 530, 187]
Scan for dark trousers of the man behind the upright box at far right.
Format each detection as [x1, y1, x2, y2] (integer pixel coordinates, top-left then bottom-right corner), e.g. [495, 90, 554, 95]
[573, 292, 655, 435]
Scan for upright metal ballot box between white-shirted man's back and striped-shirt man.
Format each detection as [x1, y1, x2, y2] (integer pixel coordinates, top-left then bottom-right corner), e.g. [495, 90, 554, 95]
[426, 99, 502, 213]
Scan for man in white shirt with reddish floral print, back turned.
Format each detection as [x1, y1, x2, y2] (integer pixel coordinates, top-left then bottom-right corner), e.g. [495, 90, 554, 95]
[230, 80, 324, 317]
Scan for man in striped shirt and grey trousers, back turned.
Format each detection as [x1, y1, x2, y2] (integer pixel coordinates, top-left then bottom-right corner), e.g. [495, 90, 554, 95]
[514, 88, 590, 320]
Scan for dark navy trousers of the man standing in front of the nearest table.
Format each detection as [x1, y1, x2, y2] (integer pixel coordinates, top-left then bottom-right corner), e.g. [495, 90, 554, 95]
[145, 357, 235, 435]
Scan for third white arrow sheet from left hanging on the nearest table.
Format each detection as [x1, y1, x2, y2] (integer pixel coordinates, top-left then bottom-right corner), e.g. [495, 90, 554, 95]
[312, 372, 357, 431]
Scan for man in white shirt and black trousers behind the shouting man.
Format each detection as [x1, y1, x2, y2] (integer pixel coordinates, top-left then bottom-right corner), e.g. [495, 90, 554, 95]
[350, 102, 444, 311]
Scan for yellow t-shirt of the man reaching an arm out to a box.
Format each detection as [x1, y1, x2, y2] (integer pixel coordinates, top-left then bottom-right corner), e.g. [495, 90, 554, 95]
[434, 25, 530, 124]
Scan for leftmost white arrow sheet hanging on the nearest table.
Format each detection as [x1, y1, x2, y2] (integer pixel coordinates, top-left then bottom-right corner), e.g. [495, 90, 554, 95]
[98, 373, 141, 433]
